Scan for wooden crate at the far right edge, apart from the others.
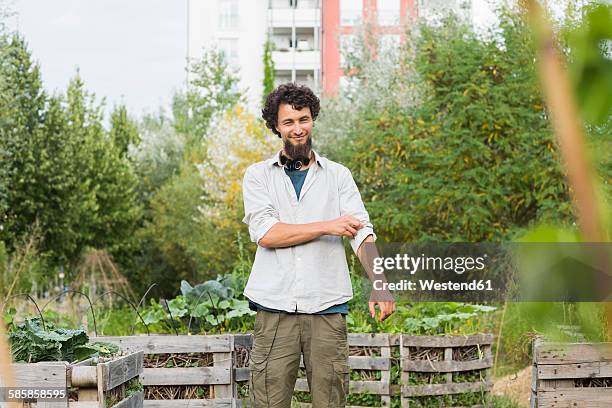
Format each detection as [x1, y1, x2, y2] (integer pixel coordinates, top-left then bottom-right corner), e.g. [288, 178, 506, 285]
[531, 339, 612, 408]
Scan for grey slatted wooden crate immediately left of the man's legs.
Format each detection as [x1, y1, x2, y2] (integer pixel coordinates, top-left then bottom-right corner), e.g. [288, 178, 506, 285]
[94, 334, 235, 408]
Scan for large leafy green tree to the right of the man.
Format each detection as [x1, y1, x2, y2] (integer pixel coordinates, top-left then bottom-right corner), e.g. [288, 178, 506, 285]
[319, 13, 574, 242]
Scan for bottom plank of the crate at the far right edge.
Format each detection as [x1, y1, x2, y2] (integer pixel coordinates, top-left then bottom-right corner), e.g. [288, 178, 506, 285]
[538, 388, 612, 408]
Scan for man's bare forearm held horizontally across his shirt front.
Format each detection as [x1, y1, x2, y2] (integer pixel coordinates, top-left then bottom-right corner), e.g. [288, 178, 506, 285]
[259, 221, 327, 248]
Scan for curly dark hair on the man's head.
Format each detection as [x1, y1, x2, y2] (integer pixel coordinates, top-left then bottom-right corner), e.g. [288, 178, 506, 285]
[261, 82, 321, 137]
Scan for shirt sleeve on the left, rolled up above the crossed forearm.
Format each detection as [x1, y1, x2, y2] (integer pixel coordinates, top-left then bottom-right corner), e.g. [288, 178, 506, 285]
[242, 166, 279, 244]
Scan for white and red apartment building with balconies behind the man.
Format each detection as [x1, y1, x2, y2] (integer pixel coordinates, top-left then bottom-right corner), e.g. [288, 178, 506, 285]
[187, 0, 472, 108]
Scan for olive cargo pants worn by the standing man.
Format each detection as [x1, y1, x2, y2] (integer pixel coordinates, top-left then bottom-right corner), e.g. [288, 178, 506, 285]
[249, 310, 349, 408]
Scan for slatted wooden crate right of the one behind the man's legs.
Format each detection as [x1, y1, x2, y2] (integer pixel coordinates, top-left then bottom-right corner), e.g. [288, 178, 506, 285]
[400, 334, 493, 407]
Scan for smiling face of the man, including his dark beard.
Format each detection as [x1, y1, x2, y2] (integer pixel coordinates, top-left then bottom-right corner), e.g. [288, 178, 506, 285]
[276, 103, 313, 159]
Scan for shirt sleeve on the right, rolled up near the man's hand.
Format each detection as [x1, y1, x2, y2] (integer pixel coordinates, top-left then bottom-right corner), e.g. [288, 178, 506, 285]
[340, 168, 376, 253]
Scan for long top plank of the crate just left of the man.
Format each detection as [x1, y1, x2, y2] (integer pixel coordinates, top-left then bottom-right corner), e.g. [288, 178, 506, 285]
[97, 334, 232, 354]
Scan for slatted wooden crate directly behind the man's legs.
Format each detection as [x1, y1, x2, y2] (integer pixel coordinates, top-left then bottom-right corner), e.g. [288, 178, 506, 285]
[234, 333, 399, 407]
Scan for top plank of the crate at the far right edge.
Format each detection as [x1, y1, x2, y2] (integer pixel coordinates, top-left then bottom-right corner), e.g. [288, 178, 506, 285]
[534, 343, 612, 365]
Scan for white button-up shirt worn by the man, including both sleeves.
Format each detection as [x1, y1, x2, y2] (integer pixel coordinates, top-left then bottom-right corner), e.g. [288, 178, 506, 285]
[242, 152, 376, 313]
